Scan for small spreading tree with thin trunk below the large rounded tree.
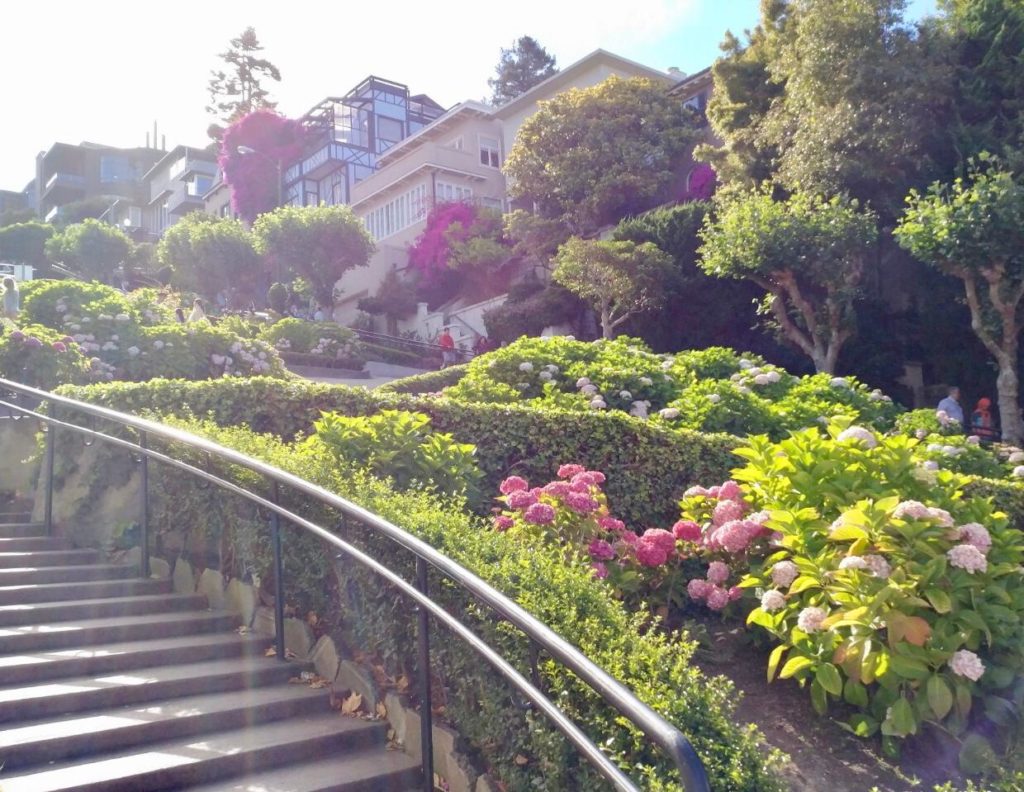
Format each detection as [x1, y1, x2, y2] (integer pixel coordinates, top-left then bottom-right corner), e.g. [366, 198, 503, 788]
[551, 237, 672, 338]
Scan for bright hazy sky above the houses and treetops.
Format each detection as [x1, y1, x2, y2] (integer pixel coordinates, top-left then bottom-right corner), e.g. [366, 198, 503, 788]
[0, 0, 935, 191]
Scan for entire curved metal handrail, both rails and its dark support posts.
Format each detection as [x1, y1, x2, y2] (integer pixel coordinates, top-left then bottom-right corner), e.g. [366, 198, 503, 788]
[0, 379, 711, 792]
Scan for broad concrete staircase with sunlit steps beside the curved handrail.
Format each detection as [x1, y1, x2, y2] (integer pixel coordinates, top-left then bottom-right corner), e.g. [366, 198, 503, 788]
[0, 514, 421, 792]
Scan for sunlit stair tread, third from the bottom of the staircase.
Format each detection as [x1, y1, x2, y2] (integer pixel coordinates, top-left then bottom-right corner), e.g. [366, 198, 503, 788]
[0, 684, 328, 753]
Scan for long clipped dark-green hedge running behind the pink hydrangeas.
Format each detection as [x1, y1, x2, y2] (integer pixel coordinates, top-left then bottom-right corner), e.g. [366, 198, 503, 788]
[58, 377, 739, 529]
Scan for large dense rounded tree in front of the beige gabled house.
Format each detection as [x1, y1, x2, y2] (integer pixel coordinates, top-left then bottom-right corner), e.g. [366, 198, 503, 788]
[505, 77, 696, 234]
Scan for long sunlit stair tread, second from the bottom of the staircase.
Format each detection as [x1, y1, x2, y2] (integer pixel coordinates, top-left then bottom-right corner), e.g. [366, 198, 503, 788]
[3, 712, 387, 792]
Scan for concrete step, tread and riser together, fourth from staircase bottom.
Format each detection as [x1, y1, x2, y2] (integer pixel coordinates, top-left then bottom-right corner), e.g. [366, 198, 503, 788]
[0, 632, 273, 684]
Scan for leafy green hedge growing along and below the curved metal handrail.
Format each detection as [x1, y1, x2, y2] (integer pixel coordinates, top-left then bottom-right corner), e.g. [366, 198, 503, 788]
[48, 413, 783, 792]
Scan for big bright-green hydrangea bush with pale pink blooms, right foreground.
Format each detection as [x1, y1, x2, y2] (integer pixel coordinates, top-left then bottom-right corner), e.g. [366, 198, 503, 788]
[712, 421, 1024, 754]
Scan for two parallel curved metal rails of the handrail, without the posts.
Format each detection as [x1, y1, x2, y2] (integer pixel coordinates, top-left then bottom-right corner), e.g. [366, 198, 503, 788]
[0, 379, 711, 792]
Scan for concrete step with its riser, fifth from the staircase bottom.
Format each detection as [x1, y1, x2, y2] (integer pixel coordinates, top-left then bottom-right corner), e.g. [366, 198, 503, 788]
[0, 611, 239, 656]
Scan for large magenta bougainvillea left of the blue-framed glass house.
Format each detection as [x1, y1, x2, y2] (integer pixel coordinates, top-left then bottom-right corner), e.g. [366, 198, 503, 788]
[217, 110, 307, 222]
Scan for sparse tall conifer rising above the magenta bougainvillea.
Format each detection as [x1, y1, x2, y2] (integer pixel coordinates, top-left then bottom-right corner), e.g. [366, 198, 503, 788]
[206, 28, 281, 139]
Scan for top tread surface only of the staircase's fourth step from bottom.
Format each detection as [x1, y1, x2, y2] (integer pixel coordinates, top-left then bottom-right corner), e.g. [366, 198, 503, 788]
[0, 632, 272, 680]
